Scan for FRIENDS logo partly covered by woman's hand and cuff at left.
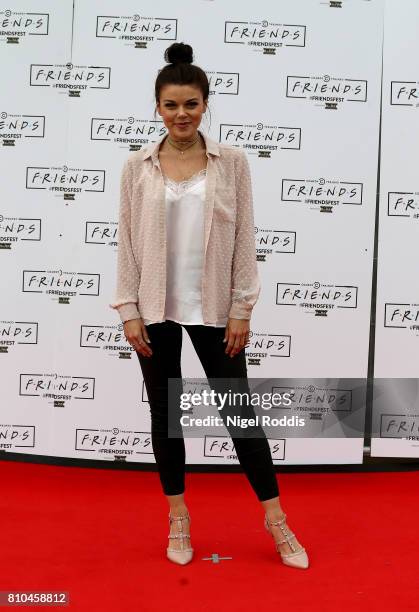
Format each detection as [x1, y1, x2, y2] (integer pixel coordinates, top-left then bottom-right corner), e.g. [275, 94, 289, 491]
[80, 323, 135, 359]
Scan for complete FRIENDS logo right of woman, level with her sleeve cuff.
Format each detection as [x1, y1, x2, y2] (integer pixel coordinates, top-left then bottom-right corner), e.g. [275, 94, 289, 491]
[275, 281, 358, 317]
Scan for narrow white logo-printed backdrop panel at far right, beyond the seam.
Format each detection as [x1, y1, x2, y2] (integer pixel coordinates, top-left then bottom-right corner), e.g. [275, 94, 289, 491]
[371, 0, 419, 457]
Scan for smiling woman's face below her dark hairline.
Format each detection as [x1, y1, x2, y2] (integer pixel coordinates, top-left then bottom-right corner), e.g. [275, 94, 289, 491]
[157, 85, 207, 140]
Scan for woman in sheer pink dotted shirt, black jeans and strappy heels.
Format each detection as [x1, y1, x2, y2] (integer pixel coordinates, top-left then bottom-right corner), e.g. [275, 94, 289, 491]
[110, 43, 308, 568]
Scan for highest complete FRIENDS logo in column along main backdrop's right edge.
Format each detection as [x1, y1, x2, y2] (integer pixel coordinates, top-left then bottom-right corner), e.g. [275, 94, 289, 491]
[286, 74, 367, 109]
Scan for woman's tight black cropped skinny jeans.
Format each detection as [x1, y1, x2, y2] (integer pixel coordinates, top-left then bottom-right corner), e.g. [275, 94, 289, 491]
[136, 320, 279, 501]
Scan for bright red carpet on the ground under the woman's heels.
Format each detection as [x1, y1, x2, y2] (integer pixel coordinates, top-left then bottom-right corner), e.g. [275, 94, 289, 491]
[0, 461, 419, 612]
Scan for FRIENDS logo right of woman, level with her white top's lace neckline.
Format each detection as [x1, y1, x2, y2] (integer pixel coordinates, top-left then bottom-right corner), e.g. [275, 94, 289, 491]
[281, 178, 364, 213]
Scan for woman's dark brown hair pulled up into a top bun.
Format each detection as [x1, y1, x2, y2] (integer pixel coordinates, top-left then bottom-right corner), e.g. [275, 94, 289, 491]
[154, 42, 209, 103]
